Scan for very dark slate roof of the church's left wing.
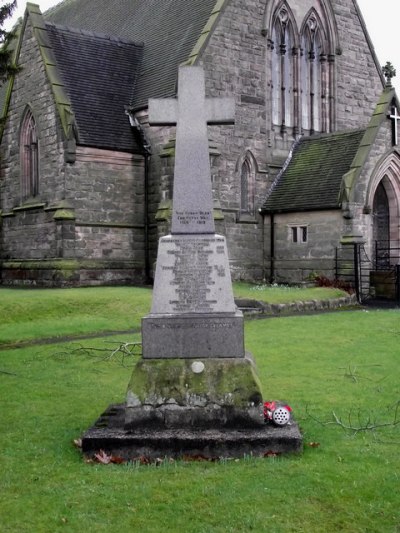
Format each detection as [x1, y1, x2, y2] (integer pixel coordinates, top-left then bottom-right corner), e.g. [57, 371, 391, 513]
[46, 23, 143, 152]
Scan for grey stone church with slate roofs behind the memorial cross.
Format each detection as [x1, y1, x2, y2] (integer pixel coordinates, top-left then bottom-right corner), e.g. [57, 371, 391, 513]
[0, 0, 400, 287]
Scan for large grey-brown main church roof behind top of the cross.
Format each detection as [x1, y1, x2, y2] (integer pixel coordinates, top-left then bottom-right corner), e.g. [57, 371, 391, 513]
[44, 0, 224, 108]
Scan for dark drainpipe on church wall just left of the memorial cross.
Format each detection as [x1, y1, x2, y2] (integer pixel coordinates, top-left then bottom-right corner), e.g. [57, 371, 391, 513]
[126, 109, 153, 284]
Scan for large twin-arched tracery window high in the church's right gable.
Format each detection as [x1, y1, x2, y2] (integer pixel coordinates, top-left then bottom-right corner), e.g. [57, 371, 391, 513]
[266, 0, 335, 136]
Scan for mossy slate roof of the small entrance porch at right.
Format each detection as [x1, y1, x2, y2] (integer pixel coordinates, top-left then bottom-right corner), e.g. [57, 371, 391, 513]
[261, 130, 365, 213]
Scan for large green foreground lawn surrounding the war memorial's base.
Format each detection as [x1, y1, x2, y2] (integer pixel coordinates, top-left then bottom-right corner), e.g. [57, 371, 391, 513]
[0, 289, 400, 533]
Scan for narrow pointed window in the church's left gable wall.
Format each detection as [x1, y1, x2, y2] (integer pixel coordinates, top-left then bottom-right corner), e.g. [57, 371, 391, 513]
[20, 108, 39, 200]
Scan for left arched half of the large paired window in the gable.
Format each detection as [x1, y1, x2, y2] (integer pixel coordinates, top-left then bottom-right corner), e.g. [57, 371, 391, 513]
[271, 3, 297, 131]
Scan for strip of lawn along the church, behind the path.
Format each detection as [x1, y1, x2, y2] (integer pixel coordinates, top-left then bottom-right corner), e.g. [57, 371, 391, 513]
[0, 283, 346, 346]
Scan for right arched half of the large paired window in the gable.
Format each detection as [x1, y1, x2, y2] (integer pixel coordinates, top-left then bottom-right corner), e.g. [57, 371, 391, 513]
[301, 11, 329, 133]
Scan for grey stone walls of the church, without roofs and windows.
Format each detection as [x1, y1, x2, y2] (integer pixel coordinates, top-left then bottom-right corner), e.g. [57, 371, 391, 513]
[0, 0, 388, 283]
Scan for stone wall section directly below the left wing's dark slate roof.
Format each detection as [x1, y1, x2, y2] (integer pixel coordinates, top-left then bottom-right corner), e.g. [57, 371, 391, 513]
[66, 147, 144, 265]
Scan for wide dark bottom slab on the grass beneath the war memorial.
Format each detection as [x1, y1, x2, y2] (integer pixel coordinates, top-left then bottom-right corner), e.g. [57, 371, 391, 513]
[82, 404, 303, 460]
